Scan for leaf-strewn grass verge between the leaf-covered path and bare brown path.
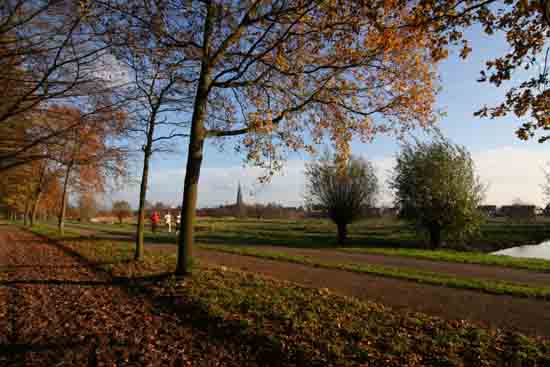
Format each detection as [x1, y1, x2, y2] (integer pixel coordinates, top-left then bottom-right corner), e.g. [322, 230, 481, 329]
[21, 228, 550, 367]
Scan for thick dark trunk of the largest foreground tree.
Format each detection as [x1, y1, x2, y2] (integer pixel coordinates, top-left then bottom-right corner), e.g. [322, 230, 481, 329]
[176, 3, 214, 276]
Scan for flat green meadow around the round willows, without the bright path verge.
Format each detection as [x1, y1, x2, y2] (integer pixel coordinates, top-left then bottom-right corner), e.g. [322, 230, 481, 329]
[62, 218, 550, 252]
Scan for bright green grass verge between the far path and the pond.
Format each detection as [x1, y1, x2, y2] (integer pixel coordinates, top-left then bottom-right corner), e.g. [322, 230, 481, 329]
[340, 247, 550, 272]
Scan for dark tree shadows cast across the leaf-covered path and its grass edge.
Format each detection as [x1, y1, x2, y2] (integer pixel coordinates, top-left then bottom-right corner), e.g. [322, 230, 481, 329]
[0, 229, 318, 366]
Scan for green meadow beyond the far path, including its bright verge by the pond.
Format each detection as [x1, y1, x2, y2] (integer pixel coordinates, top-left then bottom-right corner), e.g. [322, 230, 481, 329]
[20, 218, 550, 271]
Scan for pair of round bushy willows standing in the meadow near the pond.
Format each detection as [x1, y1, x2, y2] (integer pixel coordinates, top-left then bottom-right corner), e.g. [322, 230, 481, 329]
[306, 137, 485, 248]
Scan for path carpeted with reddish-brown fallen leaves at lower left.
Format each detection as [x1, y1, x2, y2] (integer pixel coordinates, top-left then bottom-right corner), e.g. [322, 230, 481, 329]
[0, 225, 266, 366]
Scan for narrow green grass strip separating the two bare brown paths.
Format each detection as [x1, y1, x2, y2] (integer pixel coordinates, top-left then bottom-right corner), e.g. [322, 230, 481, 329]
[201, 245, 550, 300]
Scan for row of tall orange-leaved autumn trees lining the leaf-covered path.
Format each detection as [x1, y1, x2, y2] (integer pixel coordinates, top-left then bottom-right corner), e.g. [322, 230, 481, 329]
[0, 0, 549, 275]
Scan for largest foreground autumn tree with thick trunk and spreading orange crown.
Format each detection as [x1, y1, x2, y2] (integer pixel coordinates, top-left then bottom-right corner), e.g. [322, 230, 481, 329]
[95, 0, 492, 275]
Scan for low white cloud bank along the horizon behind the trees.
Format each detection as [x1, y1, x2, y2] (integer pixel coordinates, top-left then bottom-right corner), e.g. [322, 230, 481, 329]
[109, 146, 545, 207]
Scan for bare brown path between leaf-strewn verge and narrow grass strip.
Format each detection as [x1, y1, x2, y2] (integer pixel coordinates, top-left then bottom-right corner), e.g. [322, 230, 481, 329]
[196, 249, 550, 336]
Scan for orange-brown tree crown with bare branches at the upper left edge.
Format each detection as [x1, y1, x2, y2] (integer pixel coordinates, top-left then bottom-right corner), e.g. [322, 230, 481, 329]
[0, 0, 130, 171]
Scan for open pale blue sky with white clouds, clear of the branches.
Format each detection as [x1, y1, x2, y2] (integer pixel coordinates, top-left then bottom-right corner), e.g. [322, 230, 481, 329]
[110, 25, 550, 207]
